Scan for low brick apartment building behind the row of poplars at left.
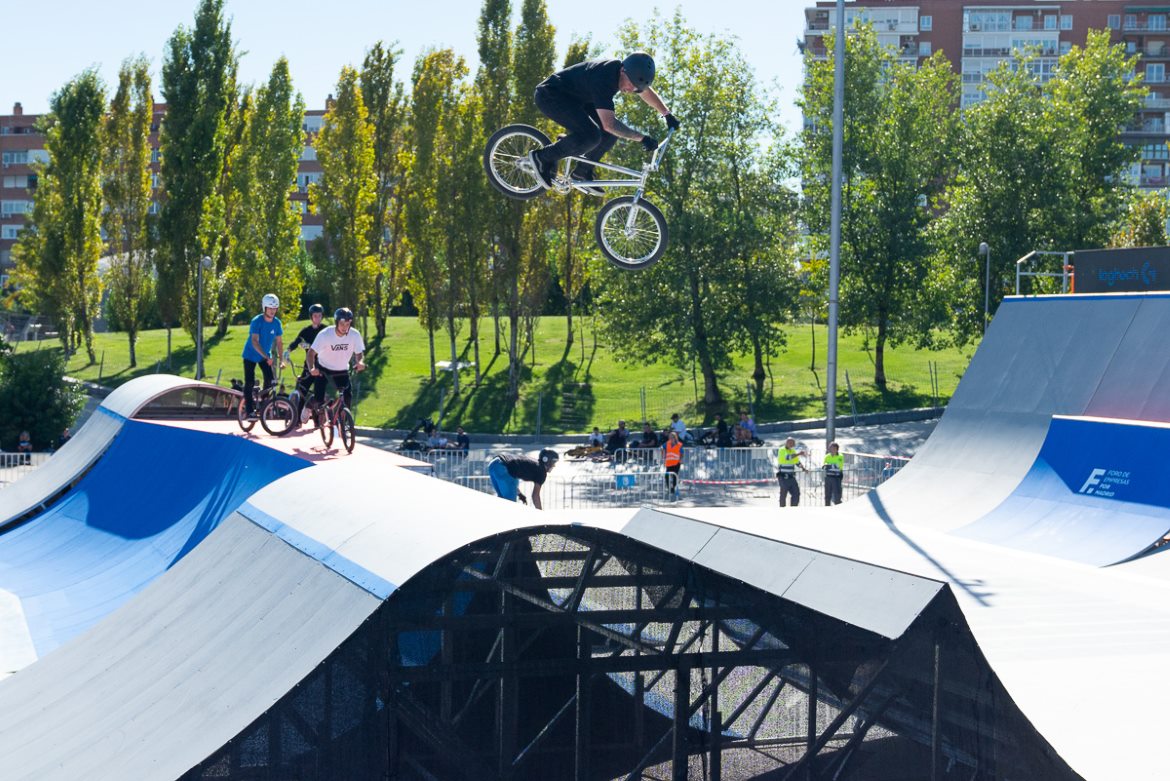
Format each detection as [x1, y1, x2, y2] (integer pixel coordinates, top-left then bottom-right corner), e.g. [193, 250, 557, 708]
[0, 103, 325, 275]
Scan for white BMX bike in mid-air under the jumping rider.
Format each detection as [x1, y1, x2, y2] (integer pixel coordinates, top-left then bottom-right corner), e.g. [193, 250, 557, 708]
[483, 124, 674, 270]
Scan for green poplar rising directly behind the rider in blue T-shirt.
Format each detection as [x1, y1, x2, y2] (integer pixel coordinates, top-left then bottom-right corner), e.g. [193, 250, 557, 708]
[229, 57, 304, 312]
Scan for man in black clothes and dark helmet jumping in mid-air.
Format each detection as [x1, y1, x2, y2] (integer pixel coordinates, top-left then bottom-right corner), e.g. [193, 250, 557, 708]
[529, 51, 679, 195]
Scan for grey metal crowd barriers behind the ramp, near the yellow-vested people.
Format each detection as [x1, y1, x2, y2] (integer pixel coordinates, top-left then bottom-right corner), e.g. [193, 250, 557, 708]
[413, 448, 909, 509]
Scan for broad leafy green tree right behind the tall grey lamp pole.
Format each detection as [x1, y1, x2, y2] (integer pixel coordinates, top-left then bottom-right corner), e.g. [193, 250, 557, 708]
[800, 25, 958, 388]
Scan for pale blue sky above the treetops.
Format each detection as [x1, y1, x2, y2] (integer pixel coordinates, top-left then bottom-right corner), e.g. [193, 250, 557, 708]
[0, 0, 811, 130]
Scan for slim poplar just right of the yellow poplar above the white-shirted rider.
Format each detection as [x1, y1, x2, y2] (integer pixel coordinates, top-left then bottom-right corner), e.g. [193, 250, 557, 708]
[362, 41, 410, 338]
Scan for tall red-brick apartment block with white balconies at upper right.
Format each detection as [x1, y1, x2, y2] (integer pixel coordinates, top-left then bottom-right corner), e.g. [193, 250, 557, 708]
[801, 0, 1170, 188]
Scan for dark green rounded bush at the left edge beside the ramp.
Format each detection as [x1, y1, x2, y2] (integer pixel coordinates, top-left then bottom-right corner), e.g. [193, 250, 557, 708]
[0, 350, 85, 451]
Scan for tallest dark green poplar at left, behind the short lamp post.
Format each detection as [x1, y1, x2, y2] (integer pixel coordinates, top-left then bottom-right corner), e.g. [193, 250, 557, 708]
[156, 0, 239, 362]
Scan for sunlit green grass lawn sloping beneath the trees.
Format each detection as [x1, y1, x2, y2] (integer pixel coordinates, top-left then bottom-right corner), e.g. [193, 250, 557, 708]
[20, 317, 973, 434]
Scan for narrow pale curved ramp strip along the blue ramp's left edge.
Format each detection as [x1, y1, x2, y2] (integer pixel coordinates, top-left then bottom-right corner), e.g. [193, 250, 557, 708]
[0, 374, 232, 530]
